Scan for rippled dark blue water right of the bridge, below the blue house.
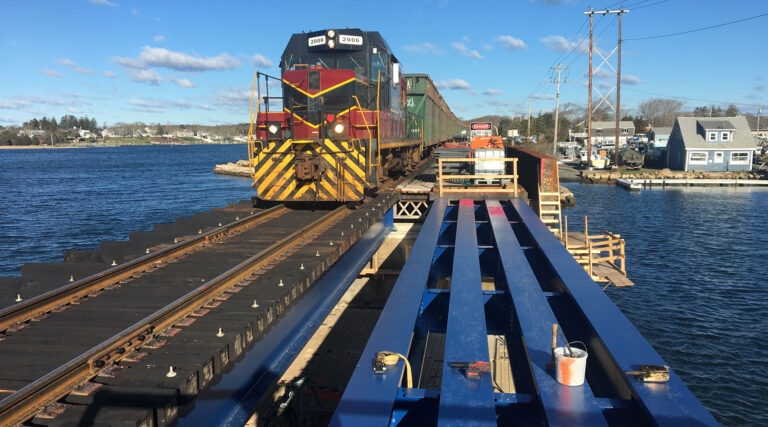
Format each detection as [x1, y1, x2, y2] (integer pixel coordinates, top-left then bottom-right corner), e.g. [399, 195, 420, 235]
[563, 183, 768, 425]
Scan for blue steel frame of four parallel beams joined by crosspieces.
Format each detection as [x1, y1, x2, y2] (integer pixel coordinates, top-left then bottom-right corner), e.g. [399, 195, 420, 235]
[332, 199, 717, 426]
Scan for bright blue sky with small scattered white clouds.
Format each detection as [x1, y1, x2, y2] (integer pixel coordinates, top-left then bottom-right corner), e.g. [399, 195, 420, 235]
[0, 0, 768, 126]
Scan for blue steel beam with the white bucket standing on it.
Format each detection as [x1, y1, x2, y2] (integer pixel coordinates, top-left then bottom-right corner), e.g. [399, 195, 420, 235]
[486, 200, 606, 426]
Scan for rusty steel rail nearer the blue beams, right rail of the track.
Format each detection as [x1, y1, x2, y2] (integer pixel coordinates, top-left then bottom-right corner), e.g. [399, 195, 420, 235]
[0, 206, 349, 427]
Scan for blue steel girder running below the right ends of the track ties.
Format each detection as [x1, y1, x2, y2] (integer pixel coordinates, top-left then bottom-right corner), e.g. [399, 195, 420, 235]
[178, 213, 392, 427]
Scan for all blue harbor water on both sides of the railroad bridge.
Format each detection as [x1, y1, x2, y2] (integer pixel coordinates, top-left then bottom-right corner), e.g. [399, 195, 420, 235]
[0, 145, 768, 425]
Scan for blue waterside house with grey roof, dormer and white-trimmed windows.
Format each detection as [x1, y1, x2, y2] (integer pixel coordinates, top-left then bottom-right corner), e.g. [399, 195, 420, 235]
[667, 117, 757, 172]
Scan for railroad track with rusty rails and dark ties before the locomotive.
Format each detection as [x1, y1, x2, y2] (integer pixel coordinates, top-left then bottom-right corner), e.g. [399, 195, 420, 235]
[0, 196, 394, 426]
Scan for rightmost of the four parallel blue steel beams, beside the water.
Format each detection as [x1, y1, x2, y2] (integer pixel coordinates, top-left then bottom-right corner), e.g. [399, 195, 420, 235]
[511, 200, 718, 425]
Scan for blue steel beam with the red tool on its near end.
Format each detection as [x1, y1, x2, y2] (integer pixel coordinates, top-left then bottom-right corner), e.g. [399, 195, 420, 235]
[438, 200, 496, 426]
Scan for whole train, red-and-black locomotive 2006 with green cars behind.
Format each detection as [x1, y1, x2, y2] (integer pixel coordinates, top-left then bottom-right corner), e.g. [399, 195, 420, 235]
[248, 29, 465, 202]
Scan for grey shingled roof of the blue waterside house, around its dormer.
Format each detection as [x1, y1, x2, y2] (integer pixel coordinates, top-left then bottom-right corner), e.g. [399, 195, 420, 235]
[675, 117, 757, 149]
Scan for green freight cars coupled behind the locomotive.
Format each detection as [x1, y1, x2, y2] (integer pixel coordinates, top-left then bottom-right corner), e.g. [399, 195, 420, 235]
[404, 74, 467, 146]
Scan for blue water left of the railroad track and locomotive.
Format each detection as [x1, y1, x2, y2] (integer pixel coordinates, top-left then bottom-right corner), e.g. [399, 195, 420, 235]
[0, 144, 255, 277]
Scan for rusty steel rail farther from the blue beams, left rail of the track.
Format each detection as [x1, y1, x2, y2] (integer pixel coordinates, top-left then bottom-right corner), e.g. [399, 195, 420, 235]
[0, 205, 288, 331]
